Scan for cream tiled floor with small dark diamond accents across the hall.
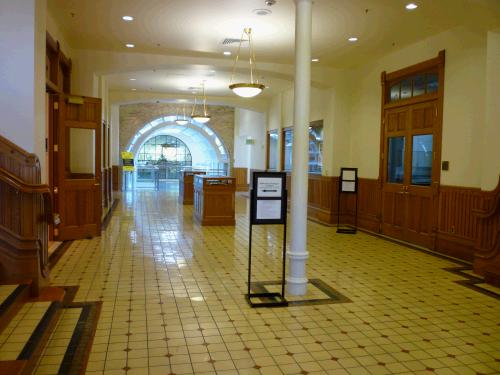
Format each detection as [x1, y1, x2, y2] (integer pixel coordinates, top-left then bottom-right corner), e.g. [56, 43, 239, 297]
[45, 187, 500, 375]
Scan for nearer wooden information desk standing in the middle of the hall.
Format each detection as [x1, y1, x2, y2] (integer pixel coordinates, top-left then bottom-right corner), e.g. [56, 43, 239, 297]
[193, 175, 236, 225]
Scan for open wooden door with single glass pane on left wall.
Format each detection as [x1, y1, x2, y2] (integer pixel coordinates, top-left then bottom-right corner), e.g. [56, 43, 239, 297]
[53, 95, 102, 240]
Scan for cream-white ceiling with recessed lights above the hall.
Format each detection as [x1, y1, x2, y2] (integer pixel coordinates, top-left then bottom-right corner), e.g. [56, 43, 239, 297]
[48, 0, 500, 96]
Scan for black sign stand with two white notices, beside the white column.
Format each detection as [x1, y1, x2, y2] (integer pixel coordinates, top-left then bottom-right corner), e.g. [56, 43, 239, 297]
[245, 172, 288, 307]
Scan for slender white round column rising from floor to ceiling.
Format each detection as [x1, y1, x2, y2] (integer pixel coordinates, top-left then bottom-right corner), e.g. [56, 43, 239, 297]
[286, 0, 312, 295]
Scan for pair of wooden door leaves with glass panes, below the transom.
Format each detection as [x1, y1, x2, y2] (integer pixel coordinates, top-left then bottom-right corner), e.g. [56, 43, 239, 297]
[382, 100, 440, 248]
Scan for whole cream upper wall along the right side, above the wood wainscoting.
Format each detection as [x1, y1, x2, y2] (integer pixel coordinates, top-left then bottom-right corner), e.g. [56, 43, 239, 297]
[268, 27, 500, 189]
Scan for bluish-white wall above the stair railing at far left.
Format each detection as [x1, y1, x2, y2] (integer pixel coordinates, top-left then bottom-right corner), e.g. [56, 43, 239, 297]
[0, 0, 46, 178]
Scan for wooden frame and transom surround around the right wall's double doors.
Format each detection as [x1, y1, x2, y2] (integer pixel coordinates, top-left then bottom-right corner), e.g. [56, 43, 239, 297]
[379, 50, 445, 247]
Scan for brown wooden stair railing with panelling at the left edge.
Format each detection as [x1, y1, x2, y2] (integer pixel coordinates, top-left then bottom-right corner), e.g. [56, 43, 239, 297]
[0, 136, 53, 295]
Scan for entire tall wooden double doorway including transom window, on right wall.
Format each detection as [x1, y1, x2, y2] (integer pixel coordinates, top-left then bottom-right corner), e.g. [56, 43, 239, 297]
[380, 52, 444, 248]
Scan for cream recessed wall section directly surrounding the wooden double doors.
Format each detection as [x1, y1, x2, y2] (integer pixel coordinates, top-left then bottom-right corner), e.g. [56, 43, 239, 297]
[350, 28, 485, 187]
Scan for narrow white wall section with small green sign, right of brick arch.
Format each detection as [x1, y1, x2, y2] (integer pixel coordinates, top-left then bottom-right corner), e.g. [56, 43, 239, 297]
[234, 108, 266, 174]
